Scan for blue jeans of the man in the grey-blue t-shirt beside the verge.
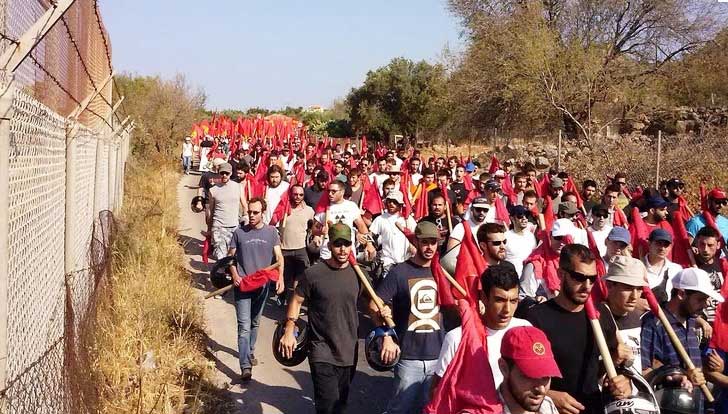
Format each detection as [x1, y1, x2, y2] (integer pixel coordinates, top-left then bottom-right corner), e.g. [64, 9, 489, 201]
[234, 284, 268, 371]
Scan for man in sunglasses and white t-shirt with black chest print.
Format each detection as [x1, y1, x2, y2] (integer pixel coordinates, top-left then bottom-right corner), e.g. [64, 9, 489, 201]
[313, 180, 376, 260]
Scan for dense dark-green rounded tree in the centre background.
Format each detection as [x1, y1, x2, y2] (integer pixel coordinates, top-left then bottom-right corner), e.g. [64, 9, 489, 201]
[346, 58, 446, 139]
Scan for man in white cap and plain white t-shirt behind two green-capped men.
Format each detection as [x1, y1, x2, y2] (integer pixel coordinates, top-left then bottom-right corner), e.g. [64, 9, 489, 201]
[369, 190, 417, 277]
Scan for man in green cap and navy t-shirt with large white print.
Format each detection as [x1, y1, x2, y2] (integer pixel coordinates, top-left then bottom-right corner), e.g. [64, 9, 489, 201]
[369, 221, 445, 414]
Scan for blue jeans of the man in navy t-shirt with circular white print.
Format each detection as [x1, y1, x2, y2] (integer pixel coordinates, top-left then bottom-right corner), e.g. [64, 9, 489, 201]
[387, 359, 437, 414]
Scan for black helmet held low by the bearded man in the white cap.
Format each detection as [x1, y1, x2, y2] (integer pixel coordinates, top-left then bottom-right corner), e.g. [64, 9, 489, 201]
[647, 365, 700, 414]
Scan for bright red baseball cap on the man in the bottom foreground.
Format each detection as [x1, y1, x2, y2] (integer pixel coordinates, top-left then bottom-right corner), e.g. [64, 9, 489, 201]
[501, 326, 561, 378]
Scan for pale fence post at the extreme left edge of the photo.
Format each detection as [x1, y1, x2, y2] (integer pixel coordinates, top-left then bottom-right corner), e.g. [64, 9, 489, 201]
[0, 86, 14, 394]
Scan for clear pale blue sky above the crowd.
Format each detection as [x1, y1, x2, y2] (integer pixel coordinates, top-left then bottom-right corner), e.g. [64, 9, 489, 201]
[100, 0, 462, 109]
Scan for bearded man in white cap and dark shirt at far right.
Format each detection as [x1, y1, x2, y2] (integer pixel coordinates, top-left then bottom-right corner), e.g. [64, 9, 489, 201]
[641, 267, 723, 413]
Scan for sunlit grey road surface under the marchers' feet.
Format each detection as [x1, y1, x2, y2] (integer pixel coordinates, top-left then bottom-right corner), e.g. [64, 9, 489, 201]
[178, 175, 392, 414]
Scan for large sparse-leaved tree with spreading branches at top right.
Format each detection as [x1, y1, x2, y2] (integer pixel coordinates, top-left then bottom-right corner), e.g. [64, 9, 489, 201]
[450, 0, 725, 142]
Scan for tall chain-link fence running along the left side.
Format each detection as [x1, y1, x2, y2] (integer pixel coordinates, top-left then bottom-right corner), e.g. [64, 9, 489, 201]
[0, 0, 132, 414]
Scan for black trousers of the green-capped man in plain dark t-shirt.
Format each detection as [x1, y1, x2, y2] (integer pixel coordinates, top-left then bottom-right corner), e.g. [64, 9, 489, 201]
[309, 359, 356, 414]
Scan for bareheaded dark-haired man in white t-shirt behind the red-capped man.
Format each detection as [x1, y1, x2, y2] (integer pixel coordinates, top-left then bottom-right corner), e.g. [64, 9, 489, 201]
[432, 262, 531, 388]
